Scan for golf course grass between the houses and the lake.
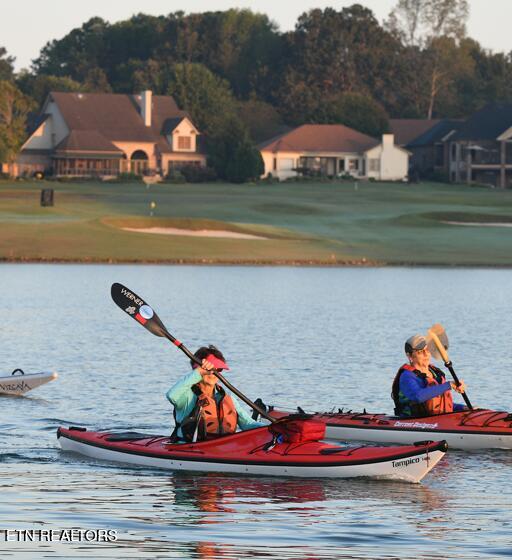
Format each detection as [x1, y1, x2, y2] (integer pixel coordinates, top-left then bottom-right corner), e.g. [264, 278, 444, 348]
[0, 181, 512, 266]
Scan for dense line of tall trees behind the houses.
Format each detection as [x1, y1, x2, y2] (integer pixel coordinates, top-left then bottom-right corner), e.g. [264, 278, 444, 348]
[0, 0, 512, 182]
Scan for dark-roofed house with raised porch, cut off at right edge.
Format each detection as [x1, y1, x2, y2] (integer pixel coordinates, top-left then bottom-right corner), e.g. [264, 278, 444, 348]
[446, 104, 512, 189]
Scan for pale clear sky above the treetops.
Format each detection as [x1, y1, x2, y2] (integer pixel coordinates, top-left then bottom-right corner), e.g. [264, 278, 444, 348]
[4, 0, 512, 70]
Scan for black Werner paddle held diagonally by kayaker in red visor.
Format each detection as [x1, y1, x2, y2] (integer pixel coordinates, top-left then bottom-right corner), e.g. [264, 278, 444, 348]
[110, 282, 276, 422]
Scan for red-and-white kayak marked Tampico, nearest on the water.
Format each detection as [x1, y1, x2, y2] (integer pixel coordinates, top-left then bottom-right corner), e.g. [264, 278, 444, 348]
[57, 427, 447, 482]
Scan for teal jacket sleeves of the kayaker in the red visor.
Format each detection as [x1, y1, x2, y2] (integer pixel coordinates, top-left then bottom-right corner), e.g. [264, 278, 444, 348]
[166, 369, 265, 437]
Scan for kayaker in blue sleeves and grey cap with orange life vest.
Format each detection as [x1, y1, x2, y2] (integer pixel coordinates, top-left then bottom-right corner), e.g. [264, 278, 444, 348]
[391, 334, 466, 417]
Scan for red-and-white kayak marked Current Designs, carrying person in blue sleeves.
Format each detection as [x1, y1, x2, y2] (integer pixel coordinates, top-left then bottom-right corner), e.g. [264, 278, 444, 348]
[269, 407, 512, 450]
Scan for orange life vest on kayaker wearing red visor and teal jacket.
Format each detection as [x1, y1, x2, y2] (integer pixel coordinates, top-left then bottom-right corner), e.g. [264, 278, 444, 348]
[192, 384, 238, 441]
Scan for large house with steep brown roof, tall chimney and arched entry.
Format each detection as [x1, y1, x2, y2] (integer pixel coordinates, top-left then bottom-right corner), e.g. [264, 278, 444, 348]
[11, 91, 206, 177]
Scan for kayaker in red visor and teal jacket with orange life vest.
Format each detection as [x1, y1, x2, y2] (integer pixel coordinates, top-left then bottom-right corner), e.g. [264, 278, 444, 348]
[166, 345, 264, 442]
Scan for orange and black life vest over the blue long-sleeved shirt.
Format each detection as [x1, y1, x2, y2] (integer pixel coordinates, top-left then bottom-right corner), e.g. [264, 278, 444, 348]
[392, 364, 453, 416]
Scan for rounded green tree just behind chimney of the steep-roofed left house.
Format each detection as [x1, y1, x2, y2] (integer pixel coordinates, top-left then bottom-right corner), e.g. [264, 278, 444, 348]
[167, 63, 236, 132]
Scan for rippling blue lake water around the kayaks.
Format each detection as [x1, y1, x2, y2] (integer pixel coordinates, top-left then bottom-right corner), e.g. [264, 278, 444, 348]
[0, 264, 512, 559]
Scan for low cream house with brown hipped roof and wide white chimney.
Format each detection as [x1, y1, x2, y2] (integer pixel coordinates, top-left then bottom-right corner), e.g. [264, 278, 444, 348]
[258, 124, 409, 181]
